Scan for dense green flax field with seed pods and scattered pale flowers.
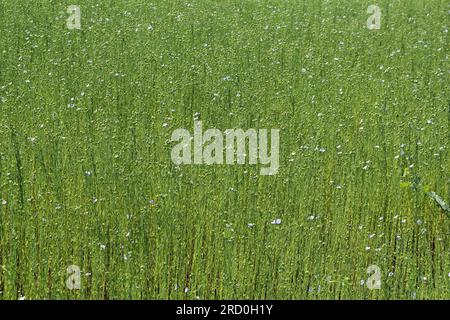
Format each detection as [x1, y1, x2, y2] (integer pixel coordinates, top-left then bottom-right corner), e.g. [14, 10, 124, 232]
[0, 0, 450, 299]
